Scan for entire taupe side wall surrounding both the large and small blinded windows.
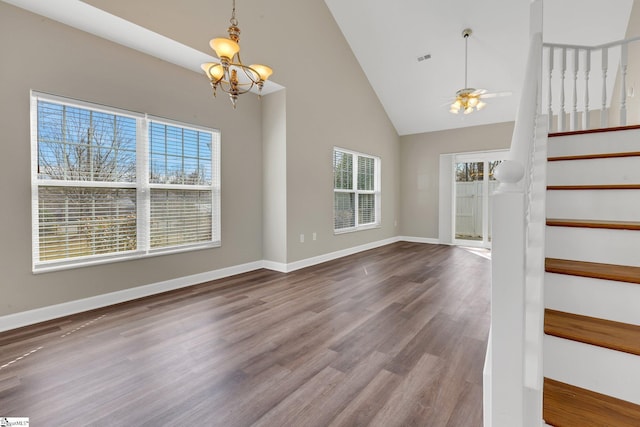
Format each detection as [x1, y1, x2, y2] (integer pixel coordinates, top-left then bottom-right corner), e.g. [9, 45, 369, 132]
[0, 0, 400, 316]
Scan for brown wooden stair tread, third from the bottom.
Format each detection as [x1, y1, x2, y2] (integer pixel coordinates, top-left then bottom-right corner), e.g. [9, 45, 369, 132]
[544, 258, 640, 284]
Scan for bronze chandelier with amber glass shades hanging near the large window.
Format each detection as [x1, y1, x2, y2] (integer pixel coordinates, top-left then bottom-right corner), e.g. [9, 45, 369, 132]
[200, 0, 273, 109]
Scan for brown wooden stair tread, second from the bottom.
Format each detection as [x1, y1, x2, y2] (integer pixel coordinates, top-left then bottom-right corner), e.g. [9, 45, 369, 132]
[544, 309, 640, 356]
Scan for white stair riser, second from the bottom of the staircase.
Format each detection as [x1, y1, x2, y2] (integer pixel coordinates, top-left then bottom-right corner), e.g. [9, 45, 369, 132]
[544, 273, 640, 325]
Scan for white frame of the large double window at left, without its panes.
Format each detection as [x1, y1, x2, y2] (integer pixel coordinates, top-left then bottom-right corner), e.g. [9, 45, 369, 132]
[30, 91, 221, 273]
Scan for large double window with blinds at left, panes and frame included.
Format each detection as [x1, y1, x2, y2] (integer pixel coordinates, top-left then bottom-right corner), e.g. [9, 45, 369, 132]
[31, 93, 220, 271]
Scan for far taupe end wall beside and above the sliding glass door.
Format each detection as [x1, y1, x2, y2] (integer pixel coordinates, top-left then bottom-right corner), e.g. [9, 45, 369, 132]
[399, 122, 513, 239]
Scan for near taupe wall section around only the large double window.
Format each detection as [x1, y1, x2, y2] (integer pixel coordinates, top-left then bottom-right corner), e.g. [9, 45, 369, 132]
[0, 2, 262, 315]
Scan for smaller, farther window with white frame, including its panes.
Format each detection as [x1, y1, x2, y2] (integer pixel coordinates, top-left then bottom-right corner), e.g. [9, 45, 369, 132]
[333, 148, 380, 233]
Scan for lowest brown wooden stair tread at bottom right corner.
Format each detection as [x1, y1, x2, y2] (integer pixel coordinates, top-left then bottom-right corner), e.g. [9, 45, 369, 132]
[543, 378, 640, 427]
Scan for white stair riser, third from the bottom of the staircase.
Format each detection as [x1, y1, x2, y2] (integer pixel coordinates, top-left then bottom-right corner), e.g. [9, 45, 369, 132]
[545, 227, 640, 267]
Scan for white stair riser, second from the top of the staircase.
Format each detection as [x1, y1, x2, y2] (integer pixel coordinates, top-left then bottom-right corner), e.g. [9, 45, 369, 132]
[547, 156, 640, 185]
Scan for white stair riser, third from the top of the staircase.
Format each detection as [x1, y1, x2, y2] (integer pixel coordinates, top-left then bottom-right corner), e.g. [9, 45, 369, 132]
[547, 190, 640, 221]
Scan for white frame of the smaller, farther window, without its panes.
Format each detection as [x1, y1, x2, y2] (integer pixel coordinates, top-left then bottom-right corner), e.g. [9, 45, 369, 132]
[331, 147, 382, 235]
